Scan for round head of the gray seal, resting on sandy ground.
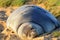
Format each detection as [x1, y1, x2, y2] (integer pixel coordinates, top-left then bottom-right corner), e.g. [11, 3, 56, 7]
[18, 22, 43, 38]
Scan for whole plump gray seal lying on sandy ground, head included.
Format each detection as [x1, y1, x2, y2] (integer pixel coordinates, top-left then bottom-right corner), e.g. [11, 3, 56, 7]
[7, 5, 59, 38]
